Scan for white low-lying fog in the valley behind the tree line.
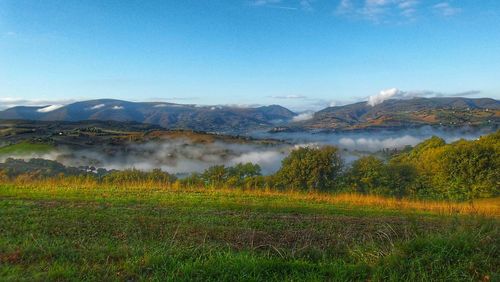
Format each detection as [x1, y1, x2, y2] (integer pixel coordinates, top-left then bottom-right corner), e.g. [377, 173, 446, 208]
[0, 127, 491, 174]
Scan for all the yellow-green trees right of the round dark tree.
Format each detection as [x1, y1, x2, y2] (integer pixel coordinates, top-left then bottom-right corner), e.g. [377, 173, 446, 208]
[346, 131, 500, 200]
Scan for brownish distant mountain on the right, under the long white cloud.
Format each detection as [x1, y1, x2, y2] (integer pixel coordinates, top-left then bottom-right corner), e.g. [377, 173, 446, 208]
[290, 98, 500, 130]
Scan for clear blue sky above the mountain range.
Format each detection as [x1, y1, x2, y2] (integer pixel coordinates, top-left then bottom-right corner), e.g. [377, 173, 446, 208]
[0, 0, 500, 110]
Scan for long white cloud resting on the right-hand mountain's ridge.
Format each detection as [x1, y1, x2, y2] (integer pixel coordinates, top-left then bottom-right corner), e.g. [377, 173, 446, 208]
[367, 88, 481, 107]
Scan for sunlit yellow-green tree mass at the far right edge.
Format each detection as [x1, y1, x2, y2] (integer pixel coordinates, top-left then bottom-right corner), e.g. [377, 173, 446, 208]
[390, 131, 500, 200]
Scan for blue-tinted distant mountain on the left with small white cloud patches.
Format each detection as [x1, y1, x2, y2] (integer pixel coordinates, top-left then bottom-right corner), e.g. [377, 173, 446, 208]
[0, 99, 295, 133]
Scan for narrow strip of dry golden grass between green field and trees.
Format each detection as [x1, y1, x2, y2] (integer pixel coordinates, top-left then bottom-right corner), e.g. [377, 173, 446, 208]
[0, 177, 500, 217]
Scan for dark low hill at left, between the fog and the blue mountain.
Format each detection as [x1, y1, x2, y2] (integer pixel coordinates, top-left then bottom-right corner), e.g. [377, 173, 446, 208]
[0, 120, 280, 150]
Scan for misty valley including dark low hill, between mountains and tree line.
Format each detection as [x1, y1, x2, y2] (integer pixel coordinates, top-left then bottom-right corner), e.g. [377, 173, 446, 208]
[0, 116, 495, 176]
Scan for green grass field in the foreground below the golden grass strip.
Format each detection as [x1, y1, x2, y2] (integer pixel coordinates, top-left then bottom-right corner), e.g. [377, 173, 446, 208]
[0, 184, 500, 281]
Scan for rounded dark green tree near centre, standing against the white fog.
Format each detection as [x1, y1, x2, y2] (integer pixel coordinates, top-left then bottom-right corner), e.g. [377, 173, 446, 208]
[276, 146, 342, 190]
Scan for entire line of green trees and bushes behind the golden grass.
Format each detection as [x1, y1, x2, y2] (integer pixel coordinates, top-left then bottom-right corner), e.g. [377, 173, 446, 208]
[0, 131, 500, 200]
